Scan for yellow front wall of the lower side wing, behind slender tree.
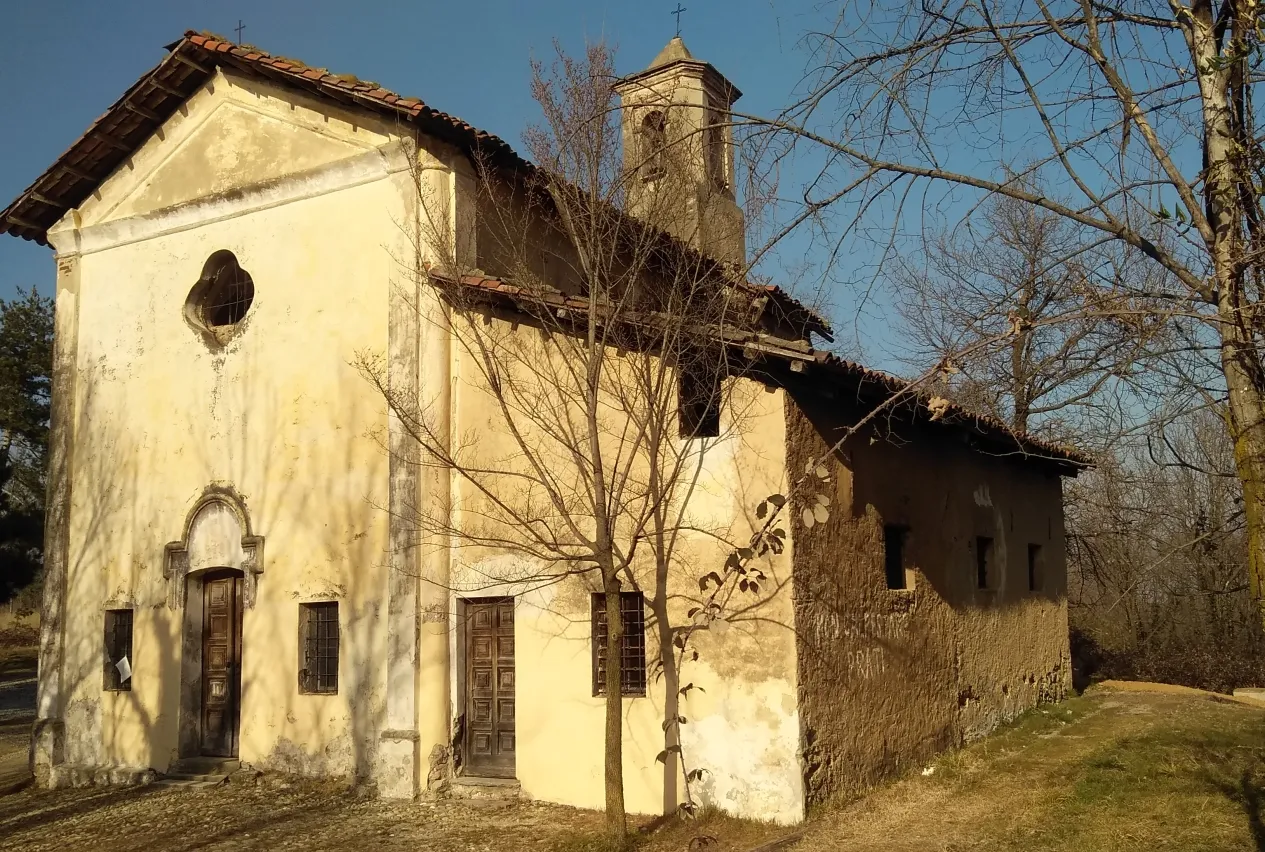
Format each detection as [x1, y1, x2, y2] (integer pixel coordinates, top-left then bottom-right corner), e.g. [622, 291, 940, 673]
[435, 308, 803, 823]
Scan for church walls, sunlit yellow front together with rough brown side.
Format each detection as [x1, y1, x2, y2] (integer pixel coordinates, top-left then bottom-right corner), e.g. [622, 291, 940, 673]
[39, 54, 1066, 822]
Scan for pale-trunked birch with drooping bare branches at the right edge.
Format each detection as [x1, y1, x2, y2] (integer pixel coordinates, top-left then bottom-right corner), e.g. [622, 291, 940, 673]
[737, 0, 1265, 618]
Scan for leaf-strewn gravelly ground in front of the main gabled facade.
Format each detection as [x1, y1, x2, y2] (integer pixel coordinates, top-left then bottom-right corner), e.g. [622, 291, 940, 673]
[0, 782, 612, 852]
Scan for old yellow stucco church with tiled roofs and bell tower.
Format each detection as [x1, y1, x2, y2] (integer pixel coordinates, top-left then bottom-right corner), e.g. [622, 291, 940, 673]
[0, 33, 1088, 823]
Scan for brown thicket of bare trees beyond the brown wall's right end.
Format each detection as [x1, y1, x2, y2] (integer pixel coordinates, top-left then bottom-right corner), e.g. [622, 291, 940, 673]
[1068, 411, 1265, 691]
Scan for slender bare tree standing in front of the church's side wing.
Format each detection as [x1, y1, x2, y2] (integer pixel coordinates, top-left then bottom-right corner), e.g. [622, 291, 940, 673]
[361, 44, 784, 848]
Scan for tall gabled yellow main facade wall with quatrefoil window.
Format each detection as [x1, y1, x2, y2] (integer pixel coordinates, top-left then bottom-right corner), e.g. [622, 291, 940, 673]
[52, 73, 407, 775]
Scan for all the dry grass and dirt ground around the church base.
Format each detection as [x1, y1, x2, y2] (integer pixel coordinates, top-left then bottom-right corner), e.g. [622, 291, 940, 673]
[0, 688, 1265, 852]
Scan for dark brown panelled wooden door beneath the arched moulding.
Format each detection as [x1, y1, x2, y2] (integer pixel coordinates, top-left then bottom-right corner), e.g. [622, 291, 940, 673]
[201, 573, 242, 757]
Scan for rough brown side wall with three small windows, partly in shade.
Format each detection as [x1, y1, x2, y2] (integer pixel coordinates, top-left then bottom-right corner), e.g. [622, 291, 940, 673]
[787, 396, 1070, 808]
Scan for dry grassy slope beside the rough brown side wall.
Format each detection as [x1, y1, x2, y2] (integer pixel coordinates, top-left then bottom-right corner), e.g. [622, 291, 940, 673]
[558, 685, 1265, 852]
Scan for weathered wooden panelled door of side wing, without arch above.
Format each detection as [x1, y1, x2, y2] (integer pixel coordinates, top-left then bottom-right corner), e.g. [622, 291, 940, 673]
[466, 598, 515, 777]
